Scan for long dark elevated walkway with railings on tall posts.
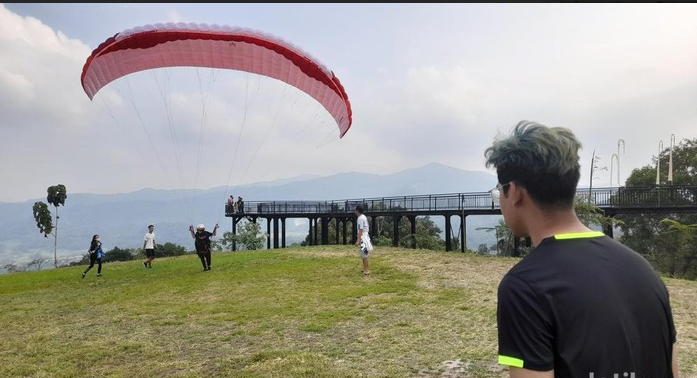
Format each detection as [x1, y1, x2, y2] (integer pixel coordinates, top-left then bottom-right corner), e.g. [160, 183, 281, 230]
[225, 186, 697, 252]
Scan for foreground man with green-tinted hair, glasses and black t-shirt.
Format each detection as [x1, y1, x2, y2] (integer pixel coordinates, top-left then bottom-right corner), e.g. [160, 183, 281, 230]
[484, 121, 678, 378]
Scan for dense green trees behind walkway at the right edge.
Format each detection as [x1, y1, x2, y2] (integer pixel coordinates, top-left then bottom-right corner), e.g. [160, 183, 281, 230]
[617, 139, 697, 279]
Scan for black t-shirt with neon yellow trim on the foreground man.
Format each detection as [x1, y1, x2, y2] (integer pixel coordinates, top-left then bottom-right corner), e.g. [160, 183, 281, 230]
[497, 232, 675, 378]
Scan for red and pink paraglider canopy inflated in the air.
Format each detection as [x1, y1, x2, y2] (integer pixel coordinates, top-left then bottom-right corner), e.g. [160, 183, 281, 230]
[81, 23, 352, 138]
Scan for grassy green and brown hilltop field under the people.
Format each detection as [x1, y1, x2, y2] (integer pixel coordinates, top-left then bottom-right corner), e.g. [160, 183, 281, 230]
[0, 246, 697, 378]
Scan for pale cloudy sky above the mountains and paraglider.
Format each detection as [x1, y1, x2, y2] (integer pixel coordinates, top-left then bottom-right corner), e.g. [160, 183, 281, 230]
[0, 3, 697, 202]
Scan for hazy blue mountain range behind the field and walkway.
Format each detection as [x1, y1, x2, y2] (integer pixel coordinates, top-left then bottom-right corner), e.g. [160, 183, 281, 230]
[0, 163, 500, 269]
